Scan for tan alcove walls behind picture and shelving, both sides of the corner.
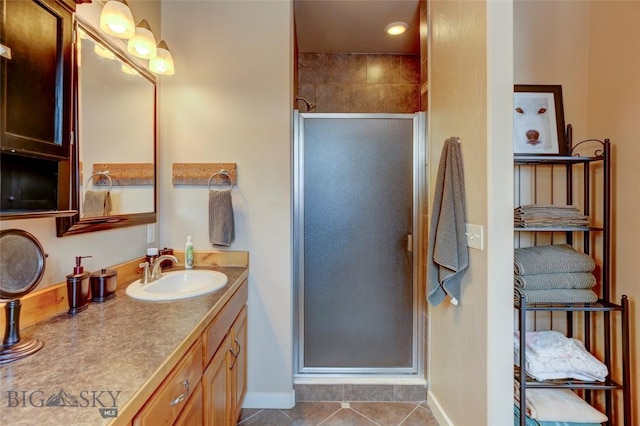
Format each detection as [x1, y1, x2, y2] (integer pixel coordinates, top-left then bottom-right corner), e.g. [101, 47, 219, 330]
[514, 1, 640, 424]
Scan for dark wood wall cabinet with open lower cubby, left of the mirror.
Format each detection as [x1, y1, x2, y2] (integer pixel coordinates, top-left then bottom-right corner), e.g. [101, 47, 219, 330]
[0, 0, 75, 219]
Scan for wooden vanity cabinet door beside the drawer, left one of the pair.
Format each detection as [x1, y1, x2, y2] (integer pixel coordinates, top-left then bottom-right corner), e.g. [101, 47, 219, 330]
[202, 333, 235, 426]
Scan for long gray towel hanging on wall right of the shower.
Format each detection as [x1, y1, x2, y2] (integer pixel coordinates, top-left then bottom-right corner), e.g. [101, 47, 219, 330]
[427, 138, 469, 306]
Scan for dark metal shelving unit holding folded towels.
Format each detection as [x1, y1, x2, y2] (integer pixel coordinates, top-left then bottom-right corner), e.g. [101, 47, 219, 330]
[514, 139, 631, 426]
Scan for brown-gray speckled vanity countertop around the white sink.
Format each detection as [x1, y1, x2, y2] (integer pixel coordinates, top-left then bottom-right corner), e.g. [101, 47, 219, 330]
[0, 267, 248, 426]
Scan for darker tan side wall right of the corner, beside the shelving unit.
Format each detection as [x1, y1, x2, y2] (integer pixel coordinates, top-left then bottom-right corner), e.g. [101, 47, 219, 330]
[586, 1, 640, 424]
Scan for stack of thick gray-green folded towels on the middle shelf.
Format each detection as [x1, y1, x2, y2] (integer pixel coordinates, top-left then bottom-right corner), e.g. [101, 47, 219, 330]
[514, 244, 598, 303]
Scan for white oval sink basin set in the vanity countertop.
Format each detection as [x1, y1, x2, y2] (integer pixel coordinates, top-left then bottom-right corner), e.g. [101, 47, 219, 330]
[125, 270, 228, 301]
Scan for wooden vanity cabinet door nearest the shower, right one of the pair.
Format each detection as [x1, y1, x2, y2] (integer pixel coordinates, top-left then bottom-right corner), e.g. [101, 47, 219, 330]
[230, 306, 247, 425]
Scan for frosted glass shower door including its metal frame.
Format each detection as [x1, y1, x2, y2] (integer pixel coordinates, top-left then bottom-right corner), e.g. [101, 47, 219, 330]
[293, 111, 426, 378]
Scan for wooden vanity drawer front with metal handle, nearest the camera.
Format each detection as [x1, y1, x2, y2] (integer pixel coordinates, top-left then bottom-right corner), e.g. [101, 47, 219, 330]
[133, 339, 202, 426]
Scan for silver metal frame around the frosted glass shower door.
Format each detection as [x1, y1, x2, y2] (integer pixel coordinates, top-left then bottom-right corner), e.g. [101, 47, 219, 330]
[292, 110, 427, 380]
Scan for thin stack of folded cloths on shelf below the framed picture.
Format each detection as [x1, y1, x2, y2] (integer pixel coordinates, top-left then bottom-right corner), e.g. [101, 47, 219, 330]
[513, 204, 589, 228]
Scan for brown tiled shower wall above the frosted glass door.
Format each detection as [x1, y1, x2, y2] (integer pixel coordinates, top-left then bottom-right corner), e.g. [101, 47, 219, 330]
[296, 53, 420, 113]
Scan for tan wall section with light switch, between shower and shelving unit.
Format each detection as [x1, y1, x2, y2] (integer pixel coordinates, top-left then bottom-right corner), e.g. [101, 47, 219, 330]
[428, 1, 513, 426]
